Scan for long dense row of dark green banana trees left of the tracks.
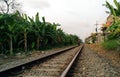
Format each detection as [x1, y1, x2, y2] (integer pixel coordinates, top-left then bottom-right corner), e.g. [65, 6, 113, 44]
[0, 11, 82, 55]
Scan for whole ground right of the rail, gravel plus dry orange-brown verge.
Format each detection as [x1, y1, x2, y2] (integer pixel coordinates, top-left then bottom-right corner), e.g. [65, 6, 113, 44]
[72, 45, 120, 77]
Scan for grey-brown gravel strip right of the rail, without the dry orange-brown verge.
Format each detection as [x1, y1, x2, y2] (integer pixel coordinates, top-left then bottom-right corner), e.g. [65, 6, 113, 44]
[71, 46, 120, 77]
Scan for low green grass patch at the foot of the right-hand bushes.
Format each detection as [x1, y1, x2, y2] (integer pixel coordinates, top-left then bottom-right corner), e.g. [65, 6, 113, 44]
[102, 39, 120, 51]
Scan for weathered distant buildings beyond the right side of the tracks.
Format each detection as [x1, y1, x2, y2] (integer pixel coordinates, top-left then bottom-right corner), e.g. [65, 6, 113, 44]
[85, 15, 115, 44]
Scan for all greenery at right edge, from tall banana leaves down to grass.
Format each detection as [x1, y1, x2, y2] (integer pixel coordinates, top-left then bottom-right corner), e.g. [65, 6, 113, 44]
[102, 0, 120, 51]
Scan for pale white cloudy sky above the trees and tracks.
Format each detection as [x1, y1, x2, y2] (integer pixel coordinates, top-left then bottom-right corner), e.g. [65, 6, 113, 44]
[19, 0, 113, 39]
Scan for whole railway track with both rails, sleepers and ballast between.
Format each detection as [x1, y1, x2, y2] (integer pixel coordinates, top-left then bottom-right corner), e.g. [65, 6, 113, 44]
[0, 45, 83, 77]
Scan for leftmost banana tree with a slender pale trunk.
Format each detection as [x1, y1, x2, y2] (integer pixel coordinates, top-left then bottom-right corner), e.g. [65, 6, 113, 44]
[2, 13, 17, 55]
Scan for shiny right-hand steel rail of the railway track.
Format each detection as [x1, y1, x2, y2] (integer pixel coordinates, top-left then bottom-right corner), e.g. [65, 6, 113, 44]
[60, 45, 83, 77]
